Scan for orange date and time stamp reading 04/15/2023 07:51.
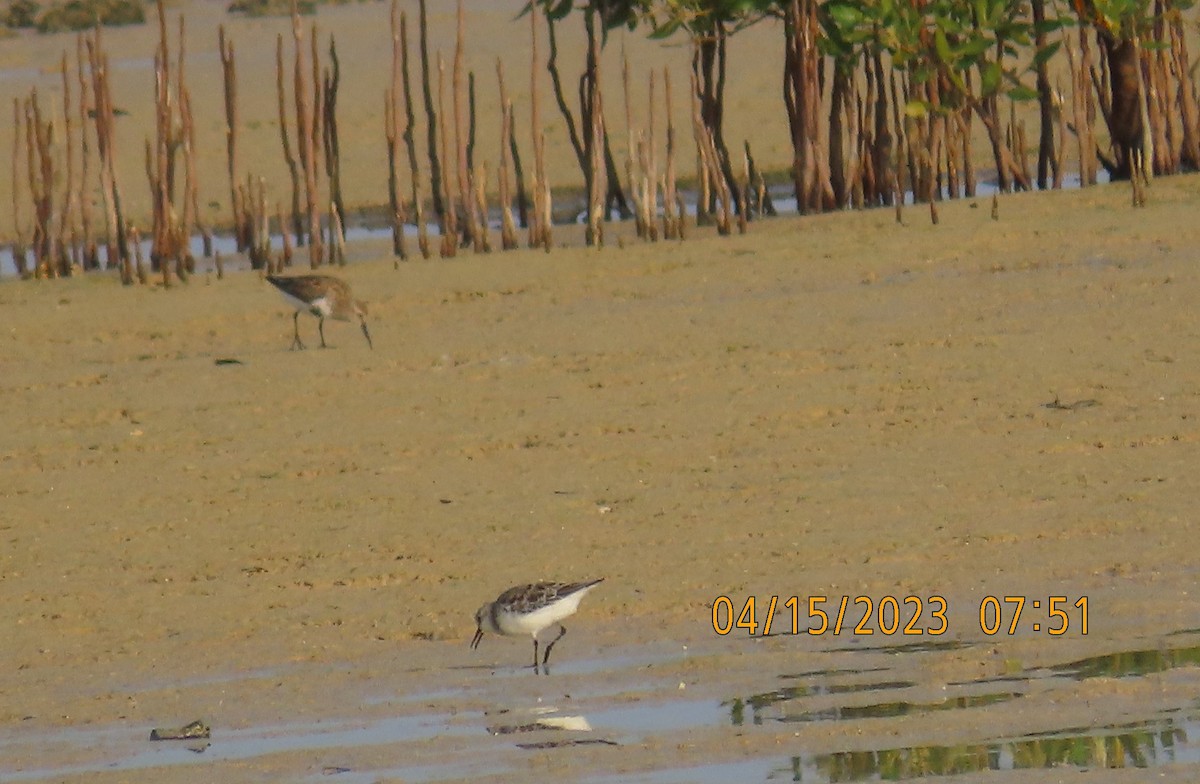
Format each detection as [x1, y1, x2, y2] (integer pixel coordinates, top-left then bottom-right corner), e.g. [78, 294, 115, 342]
[713, 596, 1087, 636]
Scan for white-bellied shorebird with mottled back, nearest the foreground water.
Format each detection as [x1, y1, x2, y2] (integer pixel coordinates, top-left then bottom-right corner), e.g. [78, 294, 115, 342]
[470, 577, 604, 670]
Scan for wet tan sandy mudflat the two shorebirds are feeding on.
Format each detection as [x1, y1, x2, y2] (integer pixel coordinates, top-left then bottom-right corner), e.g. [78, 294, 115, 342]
[7, 178, 1200, 782]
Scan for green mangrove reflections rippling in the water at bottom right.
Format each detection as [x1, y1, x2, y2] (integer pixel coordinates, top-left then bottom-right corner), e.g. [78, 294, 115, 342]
[725, 635, 1200, 783]
